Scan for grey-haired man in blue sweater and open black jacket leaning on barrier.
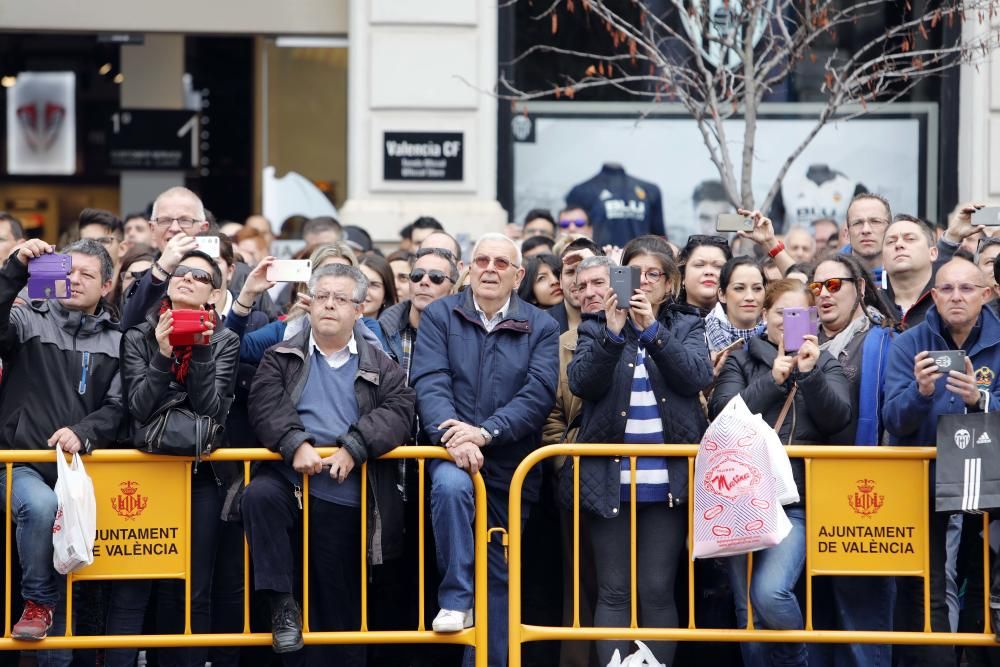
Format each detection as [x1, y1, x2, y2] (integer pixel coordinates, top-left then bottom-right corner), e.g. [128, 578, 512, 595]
[242, 264, 415, 665]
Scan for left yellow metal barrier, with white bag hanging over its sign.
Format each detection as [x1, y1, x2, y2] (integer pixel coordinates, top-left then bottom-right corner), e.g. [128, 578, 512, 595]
[0, 447, 488, 667]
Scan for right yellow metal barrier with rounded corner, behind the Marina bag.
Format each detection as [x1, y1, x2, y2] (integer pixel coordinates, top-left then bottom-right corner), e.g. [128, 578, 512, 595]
[508, 444, 996, 667]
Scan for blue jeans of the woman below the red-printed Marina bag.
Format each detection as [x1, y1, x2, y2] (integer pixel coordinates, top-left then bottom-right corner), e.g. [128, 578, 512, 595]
[727, 507, 808, 667]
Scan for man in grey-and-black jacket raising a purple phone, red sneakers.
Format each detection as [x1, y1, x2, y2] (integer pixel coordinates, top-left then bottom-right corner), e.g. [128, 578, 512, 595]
[0, 239, 122, 644]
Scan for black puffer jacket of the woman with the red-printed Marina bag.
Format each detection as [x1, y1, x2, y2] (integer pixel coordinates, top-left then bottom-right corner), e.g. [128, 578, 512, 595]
[709, 336, 854, 498]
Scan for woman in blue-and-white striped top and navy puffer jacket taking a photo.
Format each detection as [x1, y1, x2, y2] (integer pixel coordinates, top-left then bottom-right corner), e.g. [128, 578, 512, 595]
[572, 236, 712, 665]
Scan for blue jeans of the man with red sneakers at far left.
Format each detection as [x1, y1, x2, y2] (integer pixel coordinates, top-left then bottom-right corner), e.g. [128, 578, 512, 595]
[0, 465, 73, 667]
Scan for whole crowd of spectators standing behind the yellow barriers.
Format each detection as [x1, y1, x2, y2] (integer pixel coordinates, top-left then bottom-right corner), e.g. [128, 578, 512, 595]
[0, 187, 1000, 667]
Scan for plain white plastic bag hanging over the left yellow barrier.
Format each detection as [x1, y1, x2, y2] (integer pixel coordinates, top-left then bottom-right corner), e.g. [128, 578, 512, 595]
[52, 447, 97, 574]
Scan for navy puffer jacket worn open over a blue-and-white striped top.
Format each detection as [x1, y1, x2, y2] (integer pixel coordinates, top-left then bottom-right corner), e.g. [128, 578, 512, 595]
[560, 307, 712, 518]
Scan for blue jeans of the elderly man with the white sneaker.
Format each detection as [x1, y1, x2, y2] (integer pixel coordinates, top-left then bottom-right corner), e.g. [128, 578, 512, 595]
[429, 460, 530, 667]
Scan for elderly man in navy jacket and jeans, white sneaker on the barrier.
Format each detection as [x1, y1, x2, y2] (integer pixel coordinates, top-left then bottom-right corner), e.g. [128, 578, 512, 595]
[410, 234, 559, 666]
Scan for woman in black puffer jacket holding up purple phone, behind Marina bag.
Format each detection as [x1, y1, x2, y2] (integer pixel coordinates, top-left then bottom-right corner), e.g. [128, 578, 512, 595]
[710, 278, 851, 667]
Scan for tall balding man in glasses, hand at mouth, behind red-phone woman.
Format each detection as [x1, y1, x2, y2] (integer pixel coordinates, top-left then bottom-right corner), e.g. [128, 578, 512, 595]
[121, 186, 208, 331]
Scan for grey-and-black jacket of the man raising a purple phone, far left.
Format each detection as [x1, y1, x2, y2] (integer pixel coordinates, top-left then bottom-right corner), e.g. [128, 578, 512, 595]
[0, 256, 122, 484]
